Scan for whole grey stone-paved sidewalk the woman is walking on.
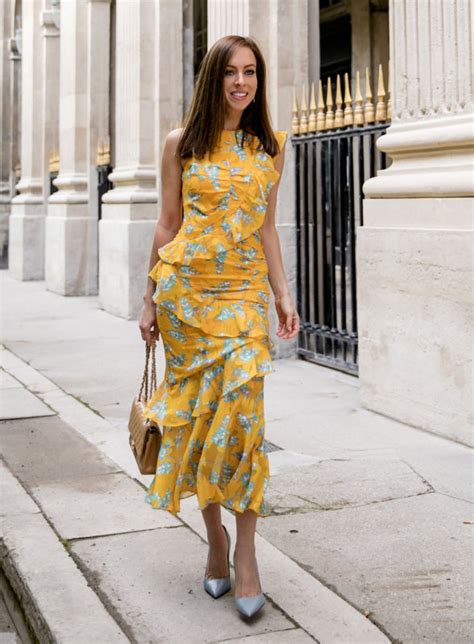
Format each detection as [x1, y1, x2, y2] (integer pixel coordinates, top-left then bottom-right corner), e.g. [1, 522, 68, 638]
[0, 271, 473, 644]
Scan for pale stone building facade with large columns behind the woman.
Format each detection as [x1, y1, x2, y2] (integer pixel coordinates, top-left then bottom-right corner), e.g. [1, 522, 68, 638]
[0, 0, 473, 443]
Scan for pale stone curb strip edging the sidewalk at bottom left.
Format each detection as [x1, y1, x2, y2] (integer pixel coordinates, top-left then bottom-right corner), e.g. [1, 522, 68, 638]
[0, 461, 130, 644]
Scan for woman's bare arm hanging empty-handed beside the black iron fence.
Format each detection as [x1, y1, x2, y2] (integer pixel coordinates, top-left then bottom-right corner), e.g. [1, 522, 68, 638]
[260, 143, 299, 340]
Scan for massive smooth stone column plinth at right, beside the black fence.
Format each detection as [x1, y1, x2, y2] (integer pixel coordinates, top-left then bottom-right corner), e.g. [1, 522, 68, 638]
[357, 198, 474, 445]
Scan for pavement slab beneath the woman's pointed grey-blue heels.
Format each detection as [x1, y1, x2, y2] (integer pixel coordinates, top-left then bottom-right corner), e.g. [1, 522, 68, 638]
[71, 526, 295, 644]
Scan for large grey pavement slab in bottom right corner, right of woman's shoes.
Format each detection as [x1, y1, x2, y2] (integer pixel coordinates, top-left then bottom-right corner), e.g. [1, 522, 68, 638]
[259, 493, 474, 644]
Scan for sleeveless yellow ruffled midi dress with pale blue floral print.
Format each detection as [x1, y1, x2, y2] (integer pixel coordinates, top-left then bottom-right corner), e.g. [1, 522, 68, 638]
[145, 130, 287, 516]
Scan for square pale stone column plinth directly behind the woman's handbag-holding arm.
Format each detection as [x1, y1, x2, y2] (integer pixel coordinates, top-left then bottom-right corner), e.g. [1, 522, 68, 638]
[99, 203, 156, 320]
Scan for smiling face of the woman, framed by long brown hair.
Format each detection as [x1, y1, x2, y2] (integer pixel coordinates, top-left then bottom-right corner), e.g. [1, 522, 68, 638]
[224, 47, 257, 116]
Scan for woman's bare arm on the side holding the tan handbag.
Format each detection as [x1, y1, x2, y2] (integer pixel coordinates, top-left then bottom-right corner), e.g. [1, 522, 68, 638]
[143, 128, 182, 305]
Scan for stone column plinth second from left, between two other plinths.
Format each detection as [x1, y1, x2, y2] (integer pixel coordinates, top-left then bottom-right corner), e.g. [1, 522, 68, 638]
[45, 203, 98, 295]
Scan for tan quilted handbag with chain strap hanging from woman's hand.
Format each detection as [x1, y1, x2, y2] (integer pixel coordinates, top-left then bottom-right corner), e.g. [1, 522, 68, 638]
[128, 340, 162, 474]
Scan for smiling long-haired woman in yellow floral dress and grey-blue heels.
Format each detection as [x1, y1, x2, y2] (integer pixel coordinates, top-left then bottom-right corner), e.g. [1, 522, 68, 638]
[140, 36, 299, 616]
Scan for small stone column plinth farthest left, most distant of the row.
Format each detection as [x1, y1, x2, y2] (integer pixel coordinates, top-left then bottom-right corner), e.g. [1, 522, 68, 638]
[8, 202, 45, 281]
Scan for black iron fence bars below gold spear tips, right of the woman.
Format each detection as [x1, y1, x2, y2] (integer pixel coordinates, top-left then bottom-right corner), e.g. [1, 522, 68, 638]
[292, 123, 389, 374]
